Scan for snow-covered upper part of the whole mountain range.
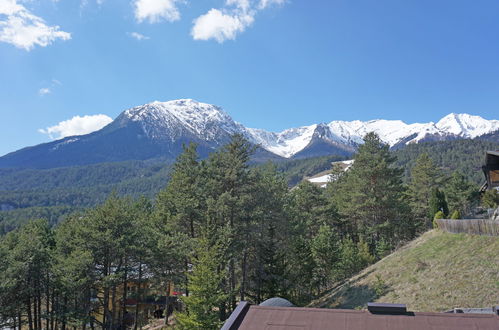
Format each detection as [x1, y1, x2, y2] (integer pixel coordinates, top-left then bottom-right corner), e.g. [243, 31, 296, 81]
[116, 99, 499, 158]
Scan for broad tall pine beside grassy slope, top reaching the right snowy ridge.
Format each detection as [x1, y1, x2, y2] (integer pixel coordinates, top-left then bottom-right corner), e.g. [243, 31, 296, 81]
[333, 133, 407, 251]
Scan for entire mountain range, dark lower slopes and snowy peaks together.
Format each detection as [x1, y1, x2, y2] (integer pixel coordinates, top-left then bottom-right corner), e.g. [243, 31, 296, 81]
[0, 99, 499, 168]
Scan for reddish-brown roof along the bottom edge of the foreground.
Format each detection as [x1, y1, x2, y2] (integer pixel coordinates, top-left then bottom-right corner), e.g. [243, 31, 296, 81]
[222, 302, 499, 330]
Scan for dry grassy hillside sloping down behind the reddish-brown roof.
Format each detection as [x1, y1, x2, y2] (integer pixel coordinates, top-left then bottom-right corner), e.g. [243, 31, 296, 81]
[310, 230, 499, 312]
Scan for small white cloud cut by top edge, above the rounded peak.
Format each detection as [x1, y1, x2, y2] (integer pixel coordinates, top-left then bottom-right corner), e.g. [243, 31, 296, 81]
[134, 0, 183, 23]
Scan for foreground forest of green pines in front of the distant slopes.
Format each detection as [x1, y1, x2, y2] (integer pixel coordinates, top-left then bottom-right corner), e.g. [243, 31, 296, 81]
[0, 133, 486, 330]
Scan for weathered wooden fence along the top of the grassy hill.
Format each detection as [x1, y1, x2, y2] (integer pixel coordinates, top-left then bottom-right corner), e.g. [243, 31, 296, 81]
[437, 219, 499, 236]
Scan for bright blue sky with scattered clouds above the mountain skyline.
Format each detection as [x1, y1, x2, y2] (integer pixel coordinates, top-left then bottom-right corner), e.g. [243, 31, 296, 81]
[0, 0, 499, 155]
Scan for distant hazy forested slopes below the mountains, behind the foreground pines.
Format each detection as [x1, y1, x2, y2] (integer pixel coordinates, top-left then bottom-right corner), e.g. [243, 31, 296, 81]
[0, 135, 499, 234]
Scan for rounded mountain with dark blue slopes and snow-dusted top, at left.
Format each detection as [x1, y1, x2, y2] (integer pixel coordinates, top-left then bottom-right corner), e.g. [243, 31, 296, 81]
[0, 100, 276, 168]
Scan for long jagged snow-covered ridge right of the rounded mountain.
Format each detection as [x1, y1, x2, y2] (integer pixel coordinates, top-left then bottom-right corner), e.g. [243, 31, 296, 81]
[248, 113, 499, 158]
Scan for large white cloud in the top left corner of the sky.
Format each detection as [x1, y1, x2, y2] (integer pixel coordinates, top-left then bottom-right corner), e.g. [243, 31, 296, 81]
[0, 0, 71, 51]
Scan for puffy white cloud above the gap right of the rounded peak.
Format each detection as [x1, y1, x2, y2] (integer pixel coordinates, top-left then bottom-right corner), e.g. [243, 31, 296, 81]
[191, 9, 254, 43]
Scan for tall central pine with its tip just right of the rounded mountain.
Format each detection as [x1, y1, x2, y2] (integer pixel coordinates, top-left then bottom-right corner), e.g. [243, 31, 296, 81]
[203, 134, 255, 313]
